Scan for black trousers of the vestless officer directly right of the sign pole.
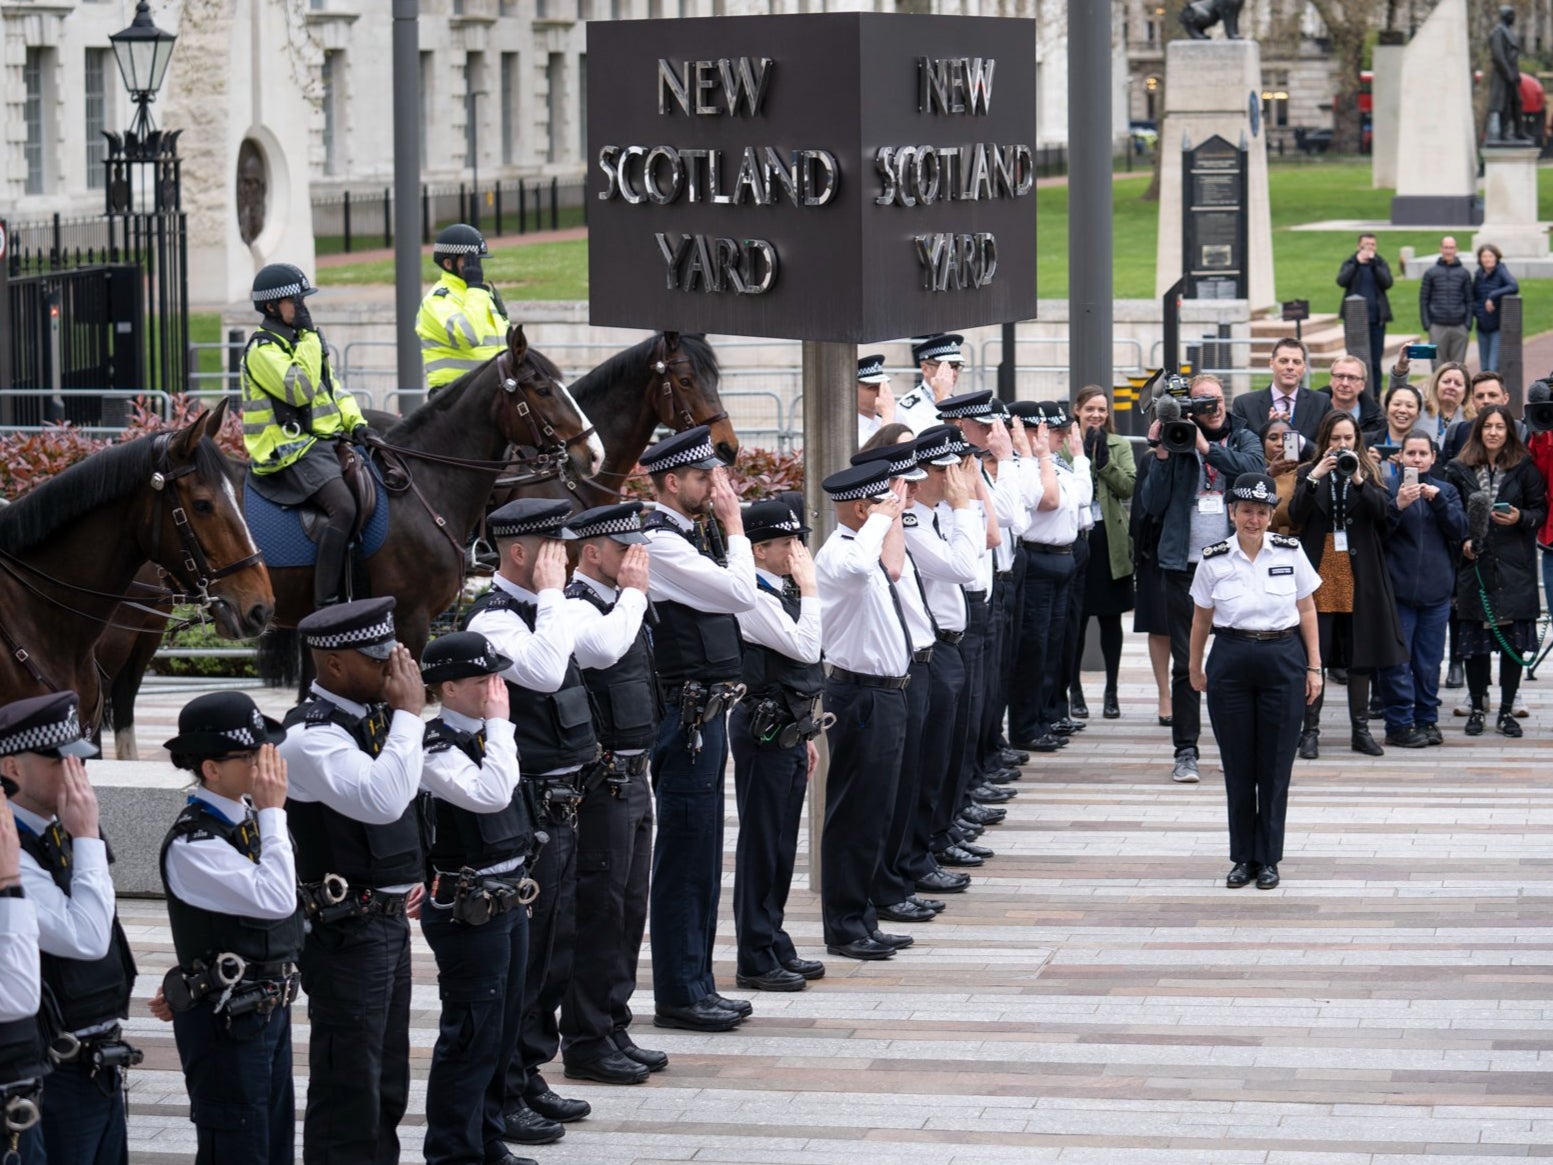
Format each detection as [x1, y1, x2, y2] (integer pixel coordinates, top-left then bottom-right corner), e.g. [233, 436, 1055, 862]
[820, 676, 907, 946]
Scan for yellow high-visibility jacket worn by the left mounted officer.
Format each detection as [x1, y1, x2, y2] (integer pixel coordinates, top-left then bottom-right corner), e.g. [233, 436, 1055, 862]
[242, 325, 367, 474]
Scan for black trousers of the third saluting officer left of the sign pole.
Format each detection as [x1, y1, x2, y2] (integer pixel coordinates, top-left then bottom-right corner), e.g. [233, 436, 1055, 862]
[561, 774, 652, 1064]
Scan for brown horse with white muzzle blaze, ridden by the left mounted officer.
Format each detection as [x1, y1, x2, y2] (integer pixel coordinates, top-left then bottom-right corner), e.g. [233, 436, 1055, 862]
[98, 326, 601, 760]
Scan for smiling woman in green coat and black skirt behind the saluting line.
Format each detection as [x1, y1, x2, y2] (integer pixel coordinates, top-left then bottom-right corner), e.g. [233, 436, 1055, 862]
[1072, 384, 1138, 721]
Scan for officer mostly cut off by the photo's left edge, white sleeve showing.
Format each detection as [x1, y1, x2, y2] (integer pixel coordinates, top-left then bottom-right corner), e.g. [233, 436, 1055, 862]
[0, 777, 48, 1165]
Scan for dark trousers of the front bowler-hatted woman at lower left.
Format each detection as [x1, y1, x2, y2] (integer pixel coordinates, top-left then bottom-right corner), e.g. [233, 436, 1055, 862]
[172, 999, 297, 1165]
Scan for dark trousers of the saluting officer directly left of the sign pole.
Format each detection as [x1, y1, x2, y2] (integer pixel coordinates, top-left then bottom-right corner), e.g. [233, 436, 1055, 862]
[728, 704, 809, 975]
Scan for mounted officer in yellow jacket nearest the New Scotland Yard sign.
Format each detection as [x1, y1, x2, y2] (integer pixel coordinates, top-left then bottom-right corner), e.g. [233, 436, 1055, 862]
[415, 222, 511, 393]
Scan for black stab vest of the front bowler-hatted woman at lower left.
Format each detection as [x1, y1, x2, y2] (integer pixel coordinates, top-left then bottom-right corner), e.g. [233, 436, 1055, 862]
[158, 800, 303, 971]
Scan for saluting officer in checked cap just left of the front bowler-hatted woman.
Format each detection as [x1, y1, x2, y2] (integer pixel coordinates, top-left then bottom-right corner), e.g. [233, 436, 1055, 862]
[0, 691, 140, 1165]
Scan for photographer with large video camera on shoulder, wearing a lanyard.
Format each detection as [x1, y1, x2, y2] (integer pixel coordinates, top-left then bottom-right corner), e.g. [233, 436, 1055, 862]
[1138, 373, 1267, 783]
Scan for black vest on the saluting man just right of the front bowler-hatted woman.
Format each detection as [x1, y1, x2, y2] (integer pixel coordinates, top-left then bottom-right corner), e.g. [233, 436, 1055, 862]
[284, 696, 421, 889]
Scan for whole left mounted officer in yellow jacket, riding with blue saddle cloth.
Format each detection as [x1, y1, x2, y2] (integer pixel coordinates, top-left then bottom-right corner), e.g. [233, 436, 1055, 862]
[242, 263, 371, 607]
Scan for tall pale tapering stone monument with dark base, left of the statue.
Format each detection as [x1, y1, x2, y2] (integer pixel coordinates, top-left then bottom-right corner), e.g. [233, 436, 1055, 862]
[1391, 0, 1482, 227]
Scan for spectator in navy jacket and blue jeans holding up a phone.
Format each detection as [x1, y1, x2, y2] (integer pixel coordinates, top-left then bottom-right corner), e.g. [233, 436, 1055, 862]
[1379, 431, 1466, 749]
